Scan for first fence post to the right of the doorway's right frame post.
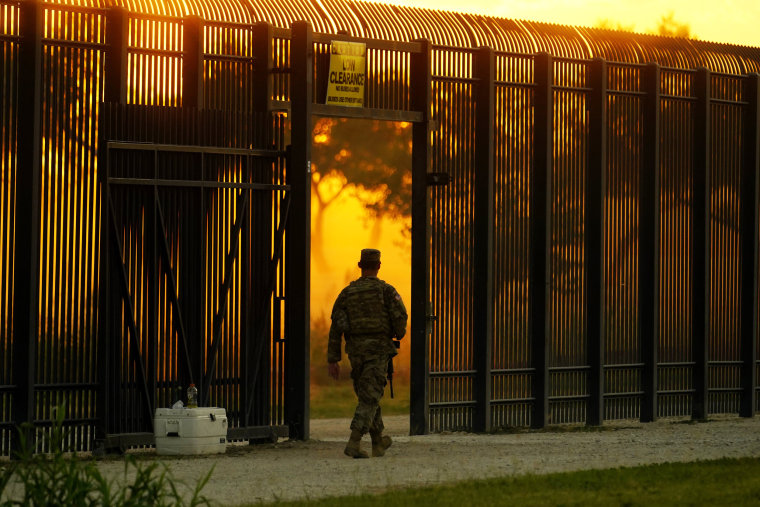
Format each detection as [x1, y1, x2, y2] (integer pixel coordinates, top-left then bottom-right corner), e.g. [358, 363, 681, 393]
[472, 47, 496, 432]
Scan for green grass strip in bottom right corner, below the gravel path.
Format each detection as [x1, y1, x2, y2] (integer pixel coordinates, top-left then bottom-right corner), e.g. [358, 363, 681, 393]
[260, 458, 760, 507]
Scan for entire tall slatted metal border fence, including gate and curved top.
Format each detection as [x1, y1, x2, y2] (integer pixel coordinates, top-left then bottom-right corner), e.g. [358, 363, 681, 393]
[0, 0, 760, 455]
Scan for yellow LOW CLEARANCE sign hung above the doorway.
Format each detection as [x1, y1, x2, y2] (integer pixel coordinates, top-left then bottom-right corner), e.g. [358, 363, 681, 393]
[325, 41, 367, 107]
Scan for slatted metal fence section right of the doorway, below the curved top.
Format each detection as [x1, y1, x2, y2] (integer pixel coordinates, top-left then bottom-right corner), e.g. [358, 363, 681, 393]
[428, 48, 758, 430]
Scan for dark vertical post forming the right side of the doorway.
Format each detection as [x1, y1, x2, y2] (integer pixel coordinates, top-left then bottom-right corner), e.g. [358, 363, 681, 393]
[409, 39, 433, 435]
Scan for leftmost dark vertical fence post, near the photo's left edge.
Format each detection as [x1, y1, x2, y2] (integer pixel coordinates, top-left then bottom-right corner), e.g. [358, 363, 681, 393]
[11, 0, 43, 451]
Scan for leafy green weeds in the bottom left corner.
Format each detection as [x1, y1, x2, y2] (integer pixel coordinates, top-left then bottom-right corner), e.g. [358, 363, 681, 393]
[0, 406, 213, 507]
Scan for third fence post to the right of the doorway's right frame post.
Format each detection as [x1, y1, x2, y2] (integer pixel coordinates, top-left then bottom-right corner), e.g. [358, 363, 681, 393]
[583, 58, 607, 426]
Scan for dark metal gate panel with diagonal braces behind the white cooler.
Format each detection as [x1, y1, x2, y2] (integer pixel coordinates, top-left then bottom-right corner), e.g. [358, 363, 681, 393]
[97, 104, 290, 449]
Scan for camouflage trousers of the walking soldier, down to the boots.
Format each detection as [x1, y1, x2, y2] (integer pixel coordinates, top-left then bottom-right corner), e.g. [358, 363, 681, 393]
[349, 356, 388, 434]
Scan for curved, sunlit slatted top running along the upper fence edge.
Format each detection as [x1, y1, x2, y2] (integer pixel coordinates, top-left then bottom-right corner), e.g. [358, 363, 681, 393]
[31, 0, 760, 74]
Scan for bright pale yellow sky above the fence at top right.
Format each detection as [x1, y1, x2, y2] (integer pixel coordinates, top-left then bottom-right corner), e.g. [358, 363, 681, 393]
[384, 0, 760, 47]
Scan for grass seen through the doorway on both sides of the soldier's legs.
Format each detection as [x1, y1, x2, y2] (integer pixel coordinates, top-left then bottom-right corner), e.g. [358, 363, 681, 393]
[310, 379, 409, 419]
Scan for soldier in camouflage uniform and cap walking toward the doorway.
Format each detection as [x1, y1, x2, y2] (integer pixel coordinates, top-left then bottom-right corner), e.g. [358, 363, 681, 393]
[327, 248, 407, 458]
